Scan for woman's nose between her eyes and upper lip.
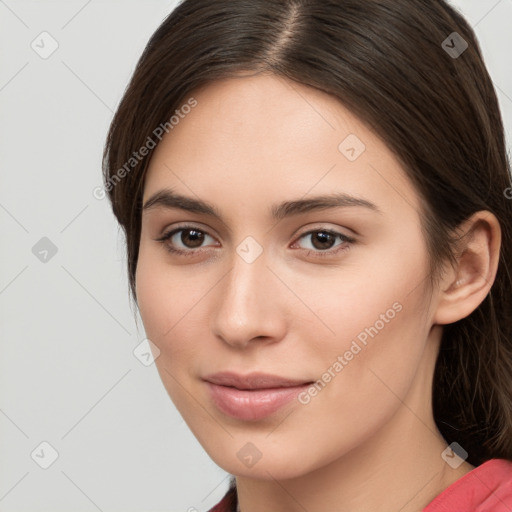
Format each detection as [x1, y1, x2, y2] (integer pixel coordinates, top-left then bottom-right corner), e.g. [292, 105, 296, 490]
[211, 252, 289, 348]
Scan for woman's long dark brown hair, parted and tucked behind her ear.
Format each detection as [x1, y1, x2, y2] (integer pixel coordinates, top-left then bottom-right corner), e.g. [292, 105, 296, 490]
[104, 0, 512, 465]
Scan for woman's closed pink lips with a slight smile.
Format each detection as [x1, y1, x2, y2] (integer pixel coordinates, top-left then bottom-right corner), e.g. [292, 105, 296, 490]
[204, 372, 312, 420]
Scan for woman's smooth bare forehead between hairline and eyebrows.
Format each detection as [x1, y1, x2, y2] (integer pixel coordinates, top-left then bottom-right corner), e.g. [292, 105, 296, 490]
[143, 75, 419, 222]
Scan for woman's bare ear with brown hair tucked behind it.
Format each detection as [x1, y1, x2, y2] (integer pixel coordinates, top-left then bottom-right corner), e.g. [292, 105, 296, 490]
[432, 211, 501, 325]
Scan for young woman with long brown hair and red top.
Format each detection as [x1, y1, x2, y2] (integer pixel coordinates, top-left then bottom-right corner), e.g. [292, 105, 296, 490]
[104, 0, 512, 512]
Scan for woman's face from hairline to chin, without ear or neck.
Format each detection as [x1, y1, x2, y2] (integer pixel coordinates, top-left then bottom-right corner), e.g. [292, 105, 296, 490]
[136, 75, 440, 479]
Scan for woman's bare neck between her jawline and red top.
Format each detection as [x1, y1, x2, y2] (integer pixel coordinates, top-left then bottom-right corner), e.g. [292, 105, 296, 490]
[237, 410, 473, 512]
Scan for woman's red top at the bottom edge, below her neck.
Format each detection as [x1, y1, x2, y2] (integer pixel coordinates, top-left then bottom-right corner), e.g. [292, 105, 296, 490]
[209, 459, 512, 512]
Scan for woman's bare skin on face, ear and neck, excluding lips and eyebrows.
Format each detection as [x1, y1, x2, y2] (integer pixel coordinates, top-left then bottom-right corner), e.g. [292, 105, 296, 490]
[136, 75, 501, 512]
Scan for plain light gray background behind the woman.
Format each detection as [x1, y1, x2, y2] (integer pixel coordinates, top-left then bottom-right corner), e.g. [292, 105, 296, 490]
[0, 0, 512, 512]
